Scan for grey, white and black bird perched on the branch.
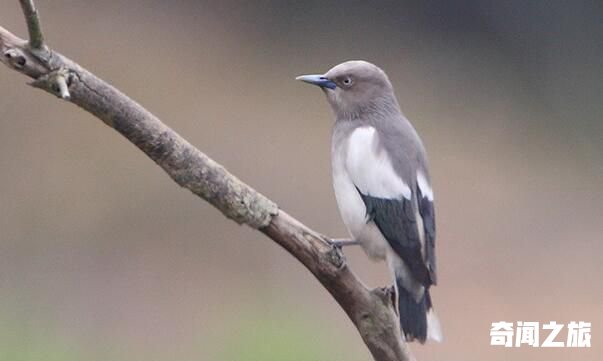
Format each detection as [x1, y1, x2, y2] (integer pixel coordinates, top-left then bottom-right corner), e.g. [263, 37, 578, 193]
[296, 61, 442, 343]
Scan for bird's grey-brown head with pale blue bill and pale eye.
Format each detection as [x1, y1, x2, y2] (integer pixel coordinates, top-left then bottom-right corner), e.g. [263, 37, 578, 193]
[296, 60, 399, 120]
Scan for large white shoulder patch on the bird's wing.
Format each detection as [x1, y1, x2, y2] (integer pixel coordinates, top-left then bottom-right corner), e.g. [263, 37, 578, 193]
[345, 127, 411, 199]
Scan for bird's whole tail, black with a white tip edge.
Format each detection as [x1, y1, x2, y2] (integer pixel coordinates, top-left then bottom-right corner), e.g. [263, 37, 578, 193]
[396, 278, 442, 343]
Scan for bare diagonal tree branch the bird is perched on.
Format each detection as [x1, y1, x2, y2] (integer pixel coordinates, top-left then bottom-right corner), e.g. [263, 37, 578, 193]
[0, 0, 414, 361]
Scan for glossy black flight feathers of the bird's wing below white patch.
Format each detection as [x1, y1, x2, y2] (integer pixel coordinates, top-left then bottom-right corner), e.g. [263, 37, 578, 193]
[358, 184, 436, 287]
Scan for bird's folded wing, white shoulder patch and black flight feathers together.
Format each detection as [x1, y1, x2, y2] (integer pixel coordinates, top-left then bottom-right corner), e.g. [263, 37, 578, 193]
[346, 127, 436, 286]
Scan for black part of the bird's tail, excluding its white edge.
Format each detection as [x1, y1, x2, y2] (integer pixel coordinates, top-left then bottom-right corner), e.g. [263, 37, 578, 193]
[396, 278, 431, 343]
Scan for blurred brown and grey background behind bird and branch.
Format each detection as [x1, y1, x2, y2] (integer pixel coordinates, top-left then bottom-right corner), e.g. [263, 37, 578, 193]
[0, 0, 603, 361]
